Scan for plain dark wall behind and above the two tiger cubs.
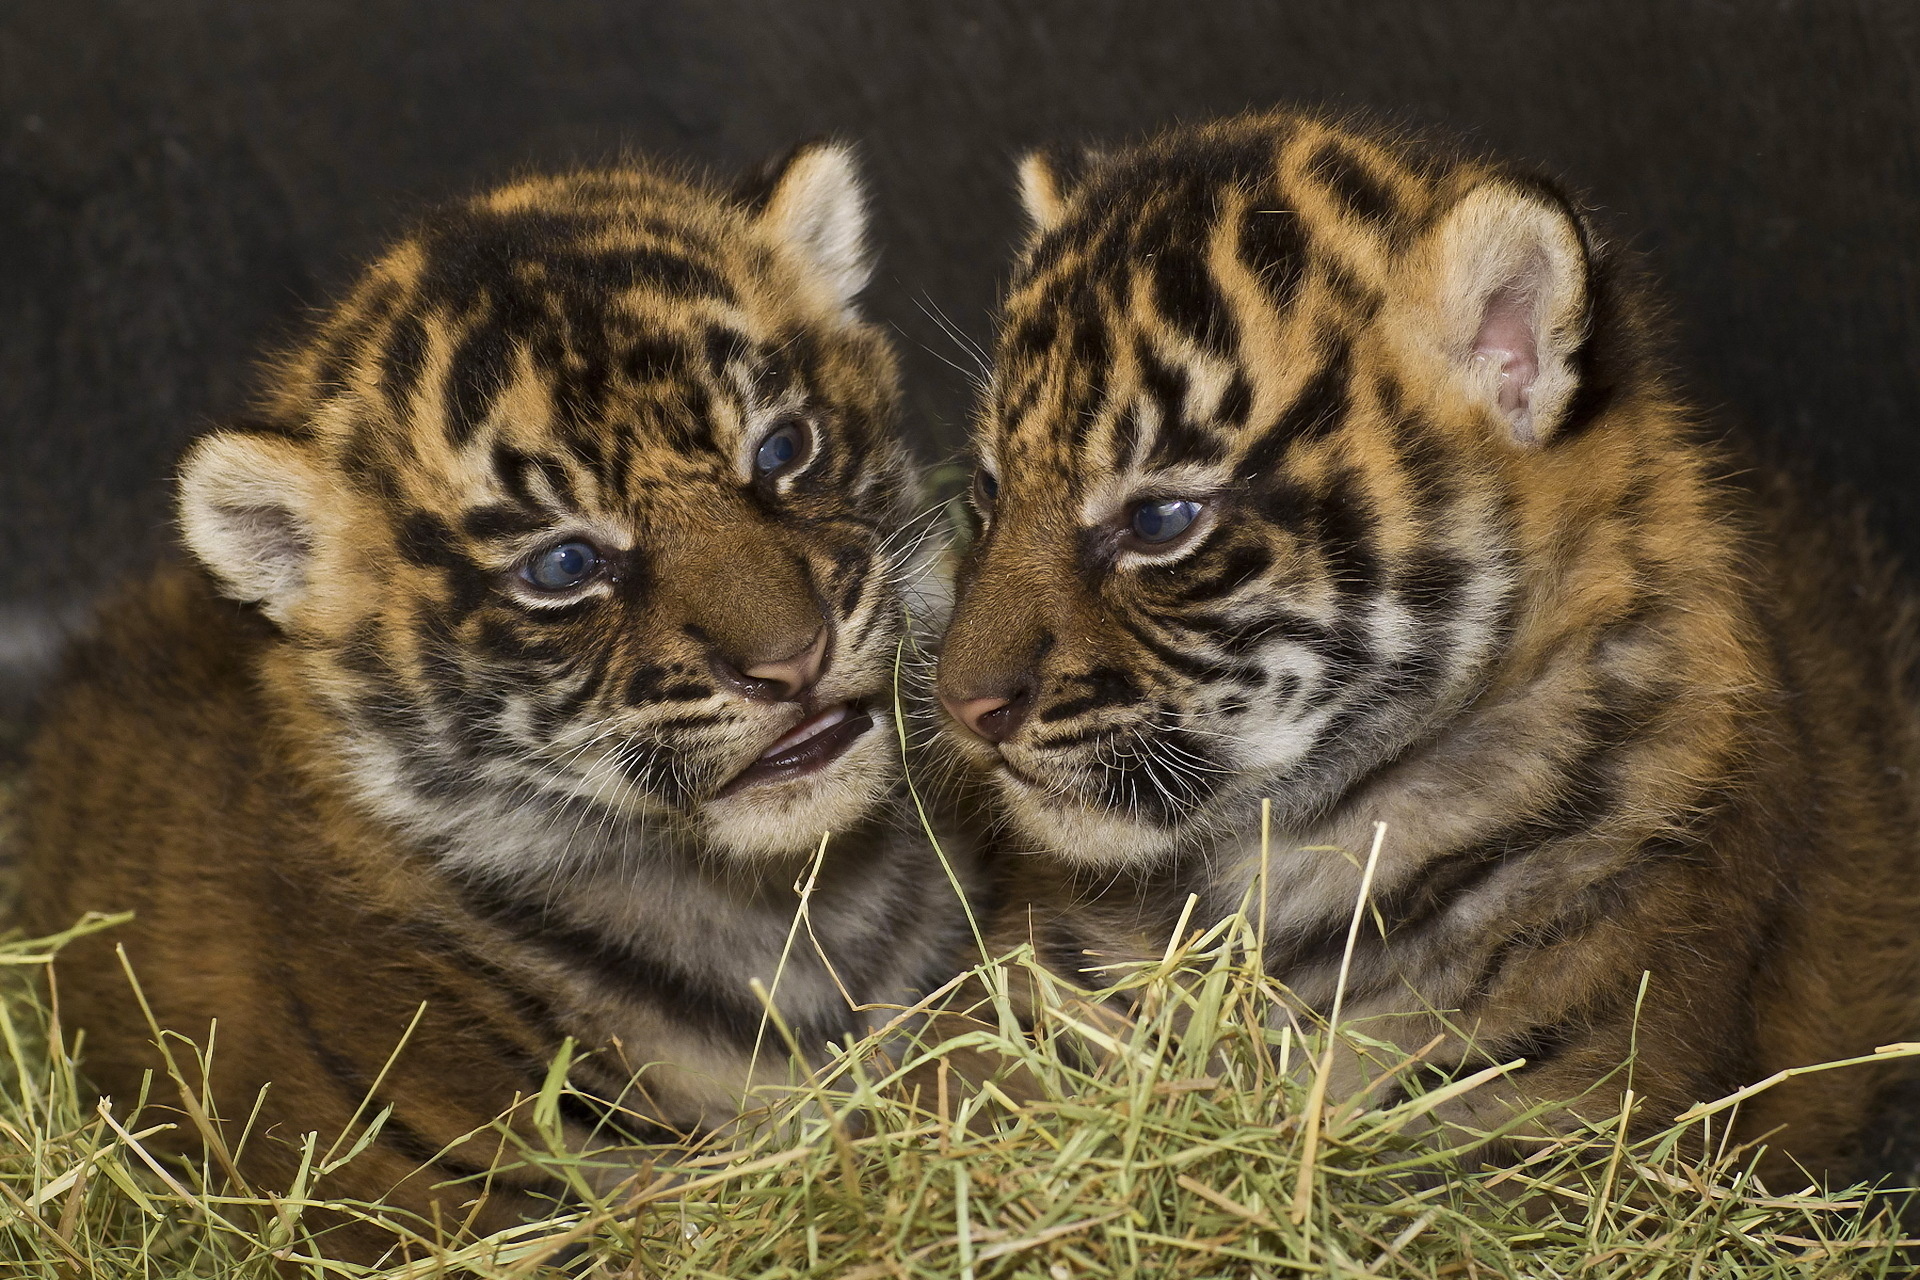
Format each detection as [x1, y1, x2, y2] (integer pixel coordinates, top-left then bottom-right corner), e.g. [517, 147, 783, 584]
[0, 0, 1920, 725]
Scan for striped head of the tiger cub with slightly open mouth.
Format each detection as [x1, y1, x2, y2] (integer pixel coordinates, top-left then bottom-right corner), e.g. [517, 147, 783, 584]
[179, 146, 916, 873]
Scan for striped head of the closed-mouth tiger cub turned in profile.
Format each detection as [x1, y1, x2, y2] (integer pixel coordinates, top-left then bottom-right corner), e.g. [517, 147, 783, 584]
[939, 115, 1659, 862]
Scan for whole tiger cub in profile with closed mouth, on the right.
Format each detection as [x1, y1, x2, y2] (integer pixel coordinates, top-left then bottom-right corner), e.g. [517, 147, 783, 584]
[939, 113, 1920, 1176]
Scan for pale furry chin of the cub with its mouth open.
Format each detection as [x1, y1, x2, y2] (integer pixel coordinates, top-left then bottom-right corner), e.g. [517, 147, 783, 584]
[699, 712, 900, 860]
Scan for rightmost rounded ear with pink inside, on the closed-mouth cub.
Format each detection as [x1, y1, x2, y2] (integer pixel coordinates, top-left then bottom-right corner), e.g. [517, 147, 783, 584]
[1428, 182, 1590, 447]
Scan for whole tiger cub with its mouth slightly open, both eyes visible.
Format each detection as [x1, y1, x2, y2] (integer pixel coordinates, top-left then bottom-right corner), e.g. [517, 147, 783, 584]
[25, 144, 972, 1253]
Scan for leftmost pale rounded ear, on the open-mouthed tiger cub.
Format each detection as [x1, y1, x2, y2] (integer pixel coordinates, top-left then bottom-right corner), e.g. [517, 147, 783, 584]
[177, 432, 323, 624]
